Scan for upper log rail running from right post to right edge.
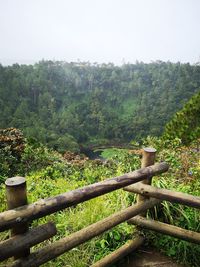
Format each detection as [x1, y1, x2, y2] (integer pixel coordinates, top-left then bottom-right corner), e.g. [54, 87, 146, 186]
[124, 183, 200, 209]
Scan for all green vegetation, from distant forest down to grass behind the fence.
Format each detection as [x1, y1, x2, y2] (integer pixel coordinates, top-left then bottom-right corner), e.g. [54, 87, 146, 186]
[0, 61, 200, 267]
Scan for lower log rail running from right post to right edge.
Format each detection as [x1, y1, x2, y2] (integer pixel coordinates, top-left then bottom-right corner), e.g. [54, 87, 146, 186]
[128, 216, 200, 244]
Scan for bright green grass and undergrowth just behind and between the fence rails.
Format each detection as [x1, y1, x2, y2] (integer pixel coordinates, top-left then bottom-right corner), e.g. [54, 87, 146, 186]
[0, 138, 200, 267]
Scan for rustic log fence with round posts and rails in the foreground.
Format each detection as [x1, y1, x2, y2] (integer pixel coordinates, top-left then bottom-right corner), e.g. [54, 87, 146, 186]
[0, 148, 200, 267]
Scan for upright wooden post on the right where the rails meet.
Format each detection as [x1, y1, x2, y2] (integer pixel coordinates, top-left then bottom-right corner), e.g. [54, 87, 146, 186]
[137, 147, 156, 216]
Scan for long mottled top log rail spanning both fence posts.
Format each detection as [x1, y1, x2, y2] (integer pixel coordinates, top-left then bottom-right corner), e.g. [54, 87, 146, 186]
[0, 162, 168, 231]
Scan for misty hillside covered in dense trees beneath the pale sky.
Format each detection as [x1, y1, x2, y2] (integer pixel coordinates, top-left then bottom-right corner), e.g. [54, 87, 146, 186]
[0, 61, 200, 151]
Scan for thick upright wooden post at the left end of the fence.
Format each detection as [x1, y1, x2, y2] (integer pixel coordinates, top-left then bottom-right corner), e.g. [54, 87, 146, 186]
[5, 176, 30, 259]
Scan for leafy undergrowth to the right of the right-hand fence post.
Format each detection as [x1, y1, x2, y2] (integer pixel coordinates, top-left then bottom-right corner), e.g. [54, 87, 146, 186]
[146, 138, 200, 267]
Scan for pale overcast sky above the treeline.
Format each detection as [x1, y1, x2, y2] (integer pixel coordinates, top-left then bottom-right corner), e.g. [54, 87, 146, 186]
[0, 0, 200, 64]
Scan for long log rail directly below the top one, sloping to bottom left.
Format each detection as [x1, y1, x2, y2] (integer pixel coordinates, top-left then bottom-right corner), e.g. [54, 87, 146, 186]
[11, 199, 160, 267]
